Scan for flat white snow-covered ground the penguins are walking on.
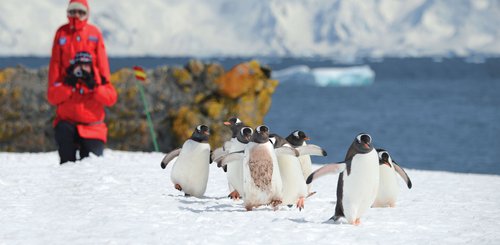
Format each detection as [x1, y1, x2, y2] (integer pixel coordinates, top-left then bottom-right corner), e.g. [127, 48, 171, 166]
[0, 150, 500, 244]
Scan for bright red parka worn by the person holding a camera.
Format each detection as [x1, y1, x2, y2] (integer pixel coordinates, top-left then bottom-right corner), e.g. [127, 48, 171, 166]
[47, 0, 117, 142]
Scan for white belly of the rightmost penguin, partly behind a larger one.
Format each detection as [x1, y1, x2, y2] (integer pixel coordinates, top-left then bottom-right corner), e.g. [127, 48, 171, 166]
[373, 164, 401, 207]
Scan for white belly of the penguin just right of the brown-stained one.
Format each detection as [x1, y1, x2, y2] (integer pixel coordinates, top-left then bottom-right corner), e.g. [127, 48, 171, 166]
[277, 154, 307, 205]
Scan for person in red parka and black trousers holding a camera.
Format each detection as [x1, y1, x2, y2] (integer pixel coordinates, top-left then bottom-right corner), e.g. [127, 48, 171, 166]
[47, 0, 117, 164]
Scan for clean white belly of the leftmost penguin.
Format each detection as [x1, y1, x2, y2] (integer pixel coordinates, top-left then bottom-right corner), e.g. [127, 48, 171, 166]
[170, 140, 210, 197]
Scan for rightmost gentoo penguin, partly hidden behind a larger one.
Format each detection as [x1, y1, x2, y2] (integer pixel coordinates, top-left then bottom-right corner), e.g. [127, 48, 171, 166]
[372, 149, 411, 207]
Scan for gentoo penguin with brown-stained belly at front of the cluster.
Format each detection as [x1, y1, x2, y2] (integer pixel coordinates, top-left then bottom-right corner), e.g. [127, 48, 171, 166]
[243, 125, 282, 211]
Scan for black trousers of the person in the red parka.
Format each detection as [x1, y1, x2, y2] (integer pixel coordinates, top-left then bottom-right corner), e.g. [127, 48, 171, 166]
[55, 121, 104, 164]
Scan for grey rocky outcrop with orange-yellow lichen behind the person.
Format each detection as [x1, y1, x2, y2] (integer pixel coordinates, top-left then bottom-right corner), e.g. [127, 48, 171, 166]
[0, 60, 278, 152]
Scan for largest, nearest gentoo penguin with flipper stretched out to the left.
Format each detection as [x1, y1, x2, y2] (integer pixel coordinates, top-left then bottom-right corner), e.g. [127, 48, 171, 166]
[306, 133, 379, 225]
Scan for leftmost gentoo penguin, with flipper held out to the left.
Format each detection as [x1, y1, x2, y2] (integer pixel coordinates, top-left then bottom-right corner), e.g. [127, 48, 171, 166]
[161, 125, 210, 197]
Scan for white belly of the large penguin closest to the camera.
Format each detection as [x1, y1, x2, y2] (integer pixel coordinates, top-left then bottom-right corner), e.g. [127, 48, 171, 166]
[342, 150, 379, 224]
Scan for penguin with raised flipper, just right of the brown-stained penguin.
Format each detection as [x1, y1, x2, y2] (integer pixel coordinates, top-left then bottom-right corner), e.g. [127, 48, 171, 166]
[271, 130, 326, 211]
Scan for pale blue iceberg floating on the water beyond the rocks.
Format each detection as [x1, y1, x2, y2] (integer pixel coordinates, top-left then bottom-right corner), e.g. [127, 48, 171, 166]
[273, 65, 375, 87]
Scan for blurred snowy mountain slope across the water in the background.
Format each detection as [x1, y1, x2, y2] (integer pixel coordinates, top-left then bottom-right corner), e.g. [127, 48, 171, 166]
[0, 0, 500, 59]
